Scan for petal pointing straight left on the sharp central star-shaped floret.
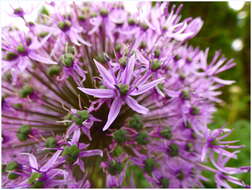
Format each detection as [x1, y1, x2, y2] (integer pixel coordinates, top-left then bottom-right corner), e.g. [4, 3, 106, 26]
[78, 87, 114, 98]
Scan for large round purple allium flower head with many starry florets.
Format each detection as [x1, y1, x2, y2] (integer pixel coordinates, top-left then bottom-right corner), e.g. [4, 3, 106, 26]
[2, 2, 250, 188]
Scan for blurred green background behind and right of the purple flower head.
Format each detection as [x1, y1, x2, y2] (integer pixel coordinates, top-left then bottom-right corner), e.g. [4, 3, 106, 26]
[130, 1, 250, 188]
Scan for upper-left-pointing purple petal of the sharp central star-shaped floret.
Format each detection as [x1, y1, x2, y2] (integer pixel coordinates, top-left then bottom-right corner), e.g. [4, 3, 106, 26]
[94, 59, 115, 89]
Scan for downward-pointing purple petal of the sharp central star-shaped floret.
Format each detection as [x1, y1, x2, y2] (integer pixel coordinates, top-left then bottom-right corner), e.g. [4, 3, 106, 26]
[102, 97, 123, 131]
